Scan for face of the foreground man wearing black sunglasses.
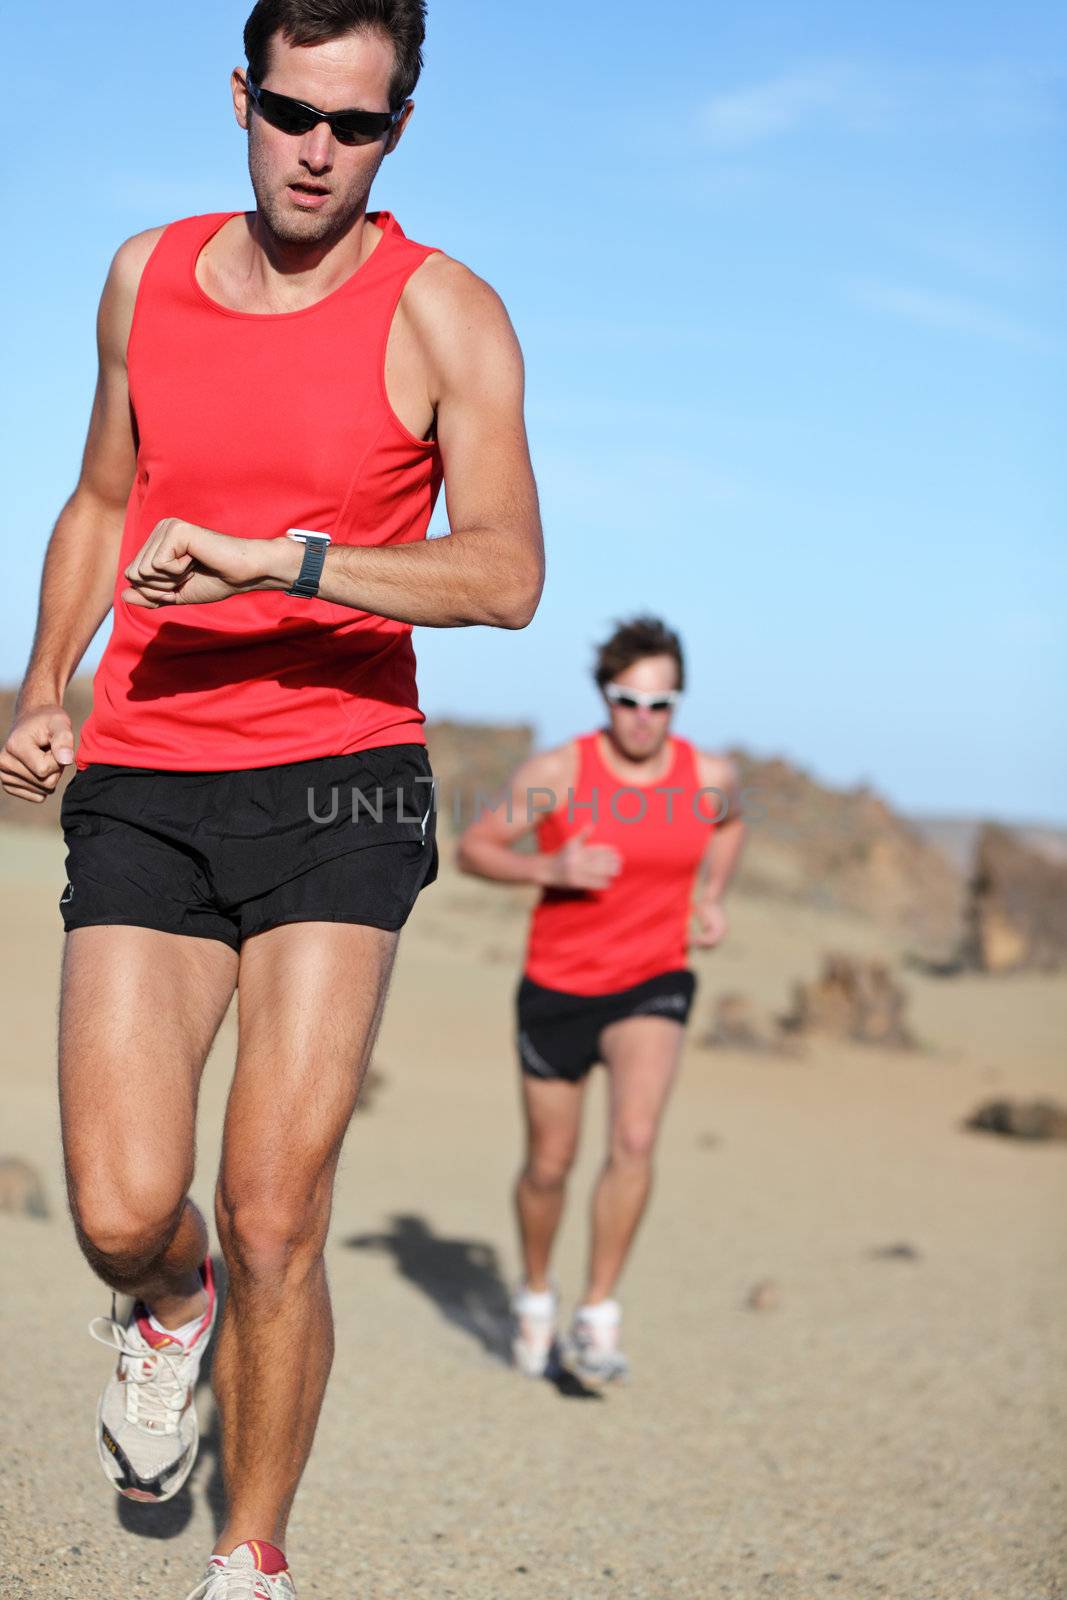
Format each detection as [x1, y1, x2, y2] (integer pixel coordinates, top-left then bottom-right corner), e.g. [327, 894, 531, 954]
[232, 34, 411, 246]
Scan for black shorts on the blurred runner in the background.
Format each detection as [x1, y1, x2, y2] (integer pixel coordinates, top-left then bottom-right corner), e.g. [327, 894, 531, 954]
[515, 971, 696, 1083]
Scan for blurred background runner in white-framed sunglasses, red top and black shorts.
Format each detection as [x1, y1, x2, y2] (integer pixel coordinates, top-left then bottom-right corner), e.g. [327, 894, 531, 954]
[459, 618, 744, 1386]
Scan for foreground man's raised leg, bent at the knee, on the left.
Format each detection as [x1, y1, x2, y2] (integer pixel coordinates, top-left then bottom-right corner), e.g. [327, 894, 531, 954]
[59, 926, 237, 1328]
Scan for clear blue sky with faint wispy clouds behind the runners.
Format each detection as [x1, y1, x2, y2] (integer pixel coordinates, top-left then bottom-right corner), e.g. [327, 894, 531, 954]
[0, 0, 1067, 821]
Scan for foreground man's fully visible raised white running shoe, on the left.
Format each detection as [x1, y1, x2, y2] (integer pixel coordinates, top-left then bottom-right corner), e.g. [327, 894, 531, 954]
[90, 1261, 219, 1504]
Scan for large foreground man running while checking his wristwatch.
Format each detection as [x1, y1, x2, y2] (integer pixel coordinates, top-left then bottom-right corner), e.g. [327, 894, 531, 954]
[0, 0, 542, 1600]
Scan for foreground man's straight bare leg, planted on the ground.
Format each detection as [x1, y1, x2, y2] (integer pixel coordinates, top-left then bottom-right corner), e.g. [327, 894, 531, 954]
[213, 922, 398, 1555]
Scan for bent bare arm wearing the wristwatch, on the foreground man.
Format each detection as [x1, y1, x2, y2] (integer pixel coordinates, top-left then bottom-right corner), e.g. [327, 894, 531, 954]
[123, 256, 544, 627]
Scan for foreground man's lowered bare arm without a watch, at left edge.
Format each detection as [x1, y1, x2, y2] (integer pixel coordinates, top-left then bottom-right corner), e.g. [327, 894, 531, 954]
[0, 229, 162, 800]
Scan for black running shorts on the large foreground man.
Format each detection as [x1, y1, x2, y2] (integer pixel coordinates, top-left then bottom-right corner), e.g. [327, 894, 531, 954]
[59, 744, 437, 950]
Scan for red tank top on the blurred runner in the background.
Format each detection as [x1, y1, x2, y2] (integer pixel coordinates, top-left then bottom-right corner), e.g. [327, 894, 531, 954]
[526, 733, 720, 995]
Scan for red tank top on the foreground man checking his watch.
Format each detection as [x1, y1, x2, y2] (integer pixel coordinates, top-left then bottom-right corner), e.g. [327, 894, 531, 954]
[77, 211, 442, 771]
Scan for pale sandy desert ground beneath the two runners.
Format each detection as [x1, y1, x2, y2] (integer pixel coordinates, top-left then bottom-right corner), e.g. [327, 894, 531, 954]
[0, 830, 1067, 1600]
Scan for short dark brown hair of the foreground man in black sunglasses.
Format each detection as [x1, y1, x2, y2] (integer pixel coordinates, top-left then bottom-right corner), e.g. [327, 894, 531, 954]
[245, 0, 426, 110]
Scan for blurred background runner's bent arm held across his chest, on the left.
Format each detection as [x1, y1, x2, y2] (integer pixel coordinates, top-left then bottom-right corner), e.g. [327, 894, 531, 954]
[456, 741, 621, 890]
